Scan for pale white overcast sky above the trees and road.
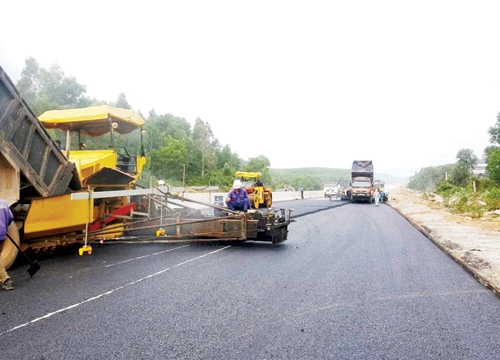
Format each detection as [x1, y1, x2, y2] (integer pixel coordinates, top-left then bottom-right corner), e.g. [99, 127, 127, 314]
[0, 0, 500, 175]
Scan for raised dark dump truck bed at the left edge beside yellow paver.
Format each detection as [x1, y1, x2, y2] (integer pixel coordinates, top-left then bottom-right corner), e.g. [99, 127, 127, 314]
[0, 67, 78, 203]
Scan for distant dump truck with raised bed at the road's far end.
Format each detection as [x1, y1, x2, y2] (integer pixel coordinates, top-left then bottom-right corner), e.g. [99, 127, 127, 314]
[349, 160, 375, 204]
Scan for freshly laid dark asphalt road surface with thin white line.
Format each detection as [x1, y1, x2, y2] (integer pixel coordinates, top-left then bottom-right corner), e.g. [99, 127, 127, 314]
[0, 199, 500, 360]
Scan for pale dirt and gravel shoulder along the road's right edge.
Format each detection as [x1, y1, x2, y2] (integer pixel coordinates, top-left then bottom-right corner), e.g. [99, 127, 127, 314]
[387, 186, 500, 296]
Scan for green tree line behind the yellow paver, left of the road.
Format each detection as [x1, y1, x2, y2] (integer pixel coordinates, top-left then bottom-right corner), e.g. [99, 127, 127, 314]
[16, 57, 348, 190]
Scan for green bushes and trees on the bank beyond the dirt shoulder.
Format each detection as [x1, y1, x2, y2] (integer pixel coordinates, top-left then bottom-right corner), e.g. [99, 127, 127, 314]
[408, 113, 500, 218]
